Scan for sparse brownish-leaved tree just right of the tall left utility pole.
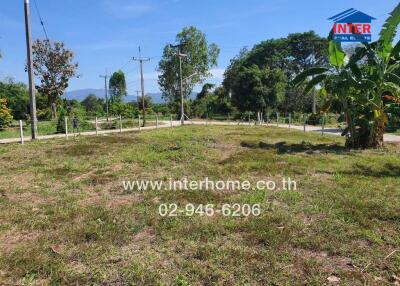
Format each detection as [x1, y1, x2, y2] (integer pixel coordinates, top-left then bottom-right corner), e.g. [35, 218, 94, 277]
[32, 40, 78, 118]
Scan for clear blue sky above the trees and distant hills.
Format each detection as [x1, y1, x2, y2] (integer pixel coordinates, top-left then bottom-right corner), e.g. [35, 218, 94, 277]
[0, 0, 398, 94]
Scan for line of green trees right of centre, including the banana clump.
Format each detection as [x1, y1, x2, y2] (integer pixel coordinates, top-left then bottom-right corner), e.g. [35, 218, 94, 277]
[158, 13, 400, 148]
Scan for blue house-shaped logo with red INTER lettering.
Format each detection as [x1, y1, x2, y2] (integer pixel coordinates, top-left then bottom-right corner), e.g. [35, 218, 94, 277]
[329, 8, 376, 42]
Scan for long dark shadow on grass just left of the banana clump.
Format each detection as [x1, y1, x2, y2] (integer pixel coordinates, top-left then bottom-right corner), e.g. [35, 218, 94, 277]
[240, 141, 352, 155]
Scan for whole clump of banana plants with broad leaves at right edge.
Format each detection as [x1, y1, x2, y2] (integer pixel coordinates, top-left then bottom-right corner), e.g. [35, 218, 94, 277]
[293, 4, 400, 148]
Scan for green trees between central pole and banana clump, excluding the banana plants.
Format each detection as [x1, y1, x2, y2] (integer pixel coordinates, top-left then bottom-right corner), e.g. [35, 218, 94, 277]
[158, 27, 329, 118]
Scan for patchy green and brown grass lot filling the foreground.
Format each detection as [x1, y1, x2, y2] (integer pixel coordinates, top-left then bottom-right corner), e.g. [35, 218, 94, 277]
[0, 126, 400, 285]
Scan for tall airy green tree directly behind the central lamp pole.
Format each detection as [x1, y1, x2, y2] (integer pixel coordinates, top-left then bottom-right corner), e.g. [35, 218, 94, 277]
[158, 27, 220, 113]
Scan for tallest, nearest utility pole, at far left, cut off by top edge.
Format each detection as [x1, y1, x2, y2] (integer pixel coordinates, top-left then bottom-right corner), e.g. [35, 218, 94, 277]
[24, 0, 37, 140]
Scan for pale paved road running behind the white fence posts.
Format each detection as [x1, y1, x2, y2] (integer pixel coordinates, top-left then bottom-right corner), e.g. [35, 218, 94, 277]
[0, 121, 400, 144]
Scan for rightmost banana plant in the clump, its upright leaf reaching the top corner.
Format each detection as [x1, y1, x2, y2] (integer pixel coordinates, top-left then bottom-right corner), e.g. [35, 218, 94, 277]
[350, 4, 400, 147]
